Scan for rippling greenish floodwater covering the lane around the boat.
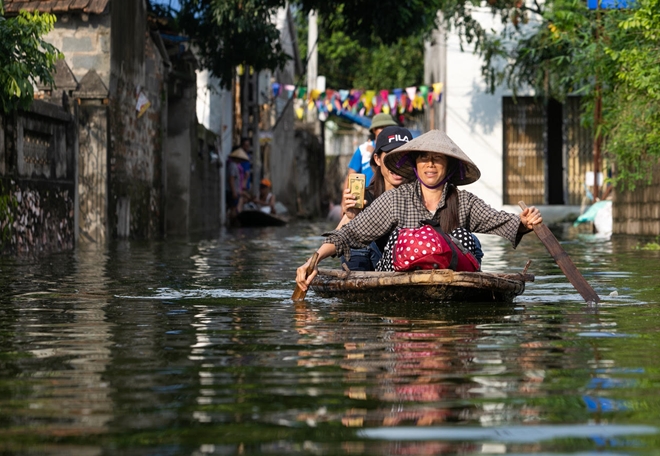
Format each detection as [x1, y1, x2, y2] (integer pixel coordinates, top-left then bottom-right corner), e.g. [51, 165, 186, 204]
[0, 222, 660, 455]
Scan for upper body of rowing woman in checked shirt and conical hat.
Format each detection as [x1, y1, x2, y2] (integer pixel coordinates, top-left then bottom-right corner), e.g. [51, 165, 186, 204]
[296, 130, 543, 290]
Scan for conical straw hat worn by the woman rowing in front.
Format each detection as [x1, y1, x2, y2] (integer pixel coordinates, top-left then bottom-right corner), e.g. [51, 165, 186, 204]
[385, 130, 481, 185]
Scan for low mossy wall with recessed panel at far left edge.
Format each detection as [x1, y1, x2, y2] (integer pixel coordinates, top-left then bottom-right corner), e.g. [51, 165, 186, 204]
[0, 101, 77, 255]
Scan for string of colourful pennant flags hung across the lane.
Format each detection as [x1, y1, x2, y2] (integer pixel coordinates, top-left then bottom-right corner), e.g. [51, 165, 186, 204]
[272, 82, 443, 119]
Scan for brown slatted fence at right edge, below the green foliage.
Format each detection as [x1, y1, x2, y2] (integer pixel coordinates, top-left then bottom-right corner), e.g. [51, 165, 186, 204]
[612, 163, 660, 236]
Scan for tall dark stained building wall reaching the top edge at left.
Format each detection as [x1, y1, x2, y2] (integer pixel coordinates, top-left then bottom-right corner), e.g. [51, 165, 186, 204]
[108, 0, 167, 238]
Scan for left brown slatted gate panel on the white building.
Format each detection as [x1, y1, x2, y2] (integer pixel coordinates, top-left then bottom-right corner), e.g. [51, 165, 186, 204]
[502, 97, 545, 205]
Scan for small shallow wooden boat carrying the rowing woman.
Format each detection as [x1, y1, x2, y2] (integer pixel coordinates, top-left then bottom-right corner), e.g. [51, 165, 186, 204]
[311, 269, 534, 303]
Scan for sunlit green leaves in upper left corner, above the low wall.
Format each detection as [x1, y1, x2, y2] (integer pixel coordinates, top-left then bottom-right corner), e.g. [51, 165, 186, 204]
[0, 11, 62, 113]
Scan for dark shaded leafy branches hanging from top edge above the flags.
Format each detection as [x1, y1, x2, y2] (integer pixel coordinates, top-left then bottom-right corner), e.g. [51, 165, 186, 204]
[179, 0, 440, 87]
